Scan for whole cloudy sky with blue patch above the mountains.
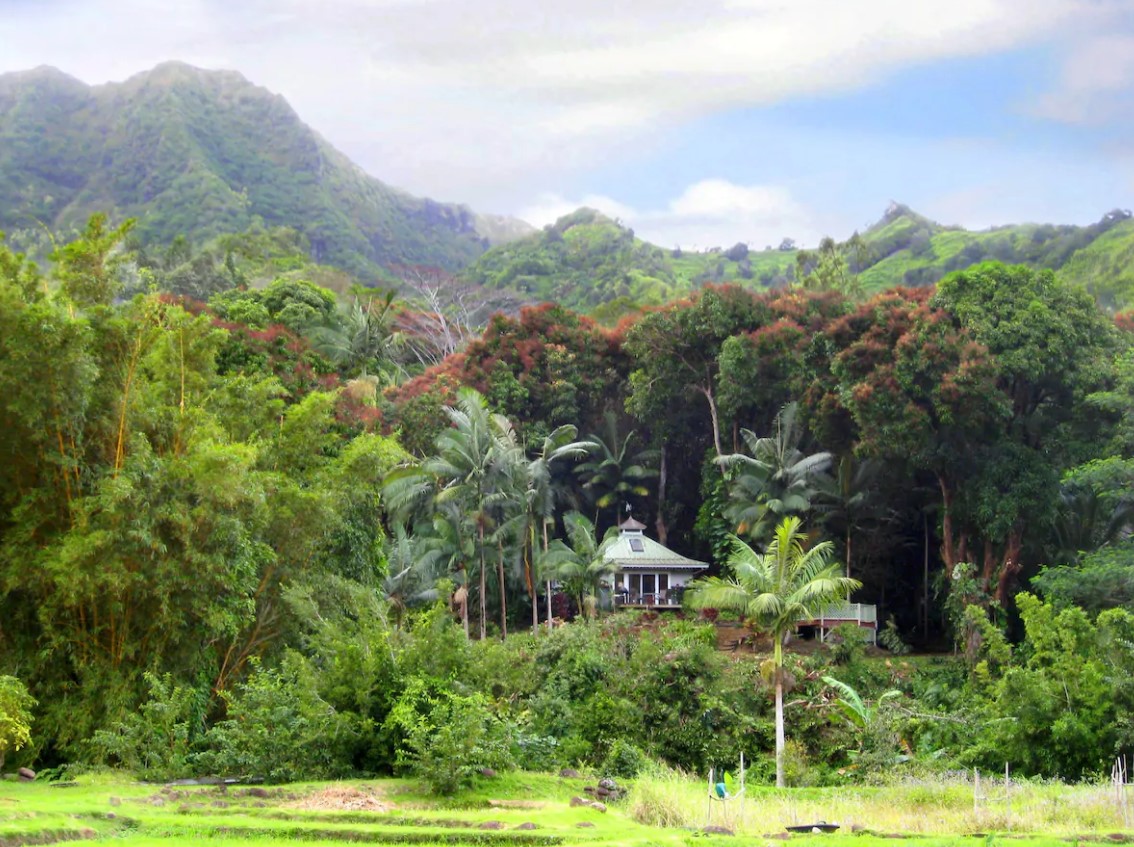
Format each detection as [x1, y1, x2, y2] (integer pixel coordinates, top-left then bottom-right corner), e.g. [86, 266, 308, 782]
[0, 0, 1134, 248]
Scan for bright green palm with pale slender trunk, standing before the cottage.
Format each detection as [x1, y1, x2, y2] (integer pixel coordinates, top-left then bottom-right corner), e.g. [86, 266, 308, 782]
[685, 516, 861, 788]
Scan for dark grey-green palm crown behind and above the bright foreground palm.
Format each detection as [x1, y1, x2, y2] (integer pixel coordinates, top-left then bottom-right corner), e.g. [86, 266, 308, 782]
[717, 403, 833, 540]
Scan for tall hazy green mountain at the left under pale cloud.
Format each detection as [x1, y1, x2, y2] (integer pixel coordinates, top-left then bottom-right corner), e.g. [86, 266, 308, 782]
[0, 62, 530, 276]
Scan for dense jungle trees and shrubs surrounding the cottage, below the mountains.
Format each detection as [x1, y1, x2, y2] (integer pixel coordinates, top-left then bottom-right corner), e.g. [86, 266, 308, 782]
[0, 217, 1134, 793]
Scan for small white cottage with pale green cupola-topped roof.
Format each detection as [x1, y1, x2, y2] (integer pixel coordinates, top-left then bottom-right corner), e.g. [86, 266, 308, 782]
[604, 517, 709, 609]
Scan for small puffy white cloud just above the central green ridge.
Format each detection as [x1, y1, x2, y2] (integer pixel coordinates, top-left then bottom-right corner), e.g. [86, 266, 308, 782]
[519, 178, 819, 249]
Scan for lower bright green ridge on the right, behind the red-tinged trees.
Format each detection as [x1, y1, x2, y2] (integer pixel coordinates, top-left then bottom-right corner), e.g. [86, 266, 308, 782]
[464, 203, 1134, 310]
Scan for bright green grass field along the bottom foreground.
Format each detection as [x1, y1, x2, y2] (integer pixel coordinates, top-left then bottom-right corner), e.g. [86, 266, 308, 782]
[0, 773, 1134, 847]
